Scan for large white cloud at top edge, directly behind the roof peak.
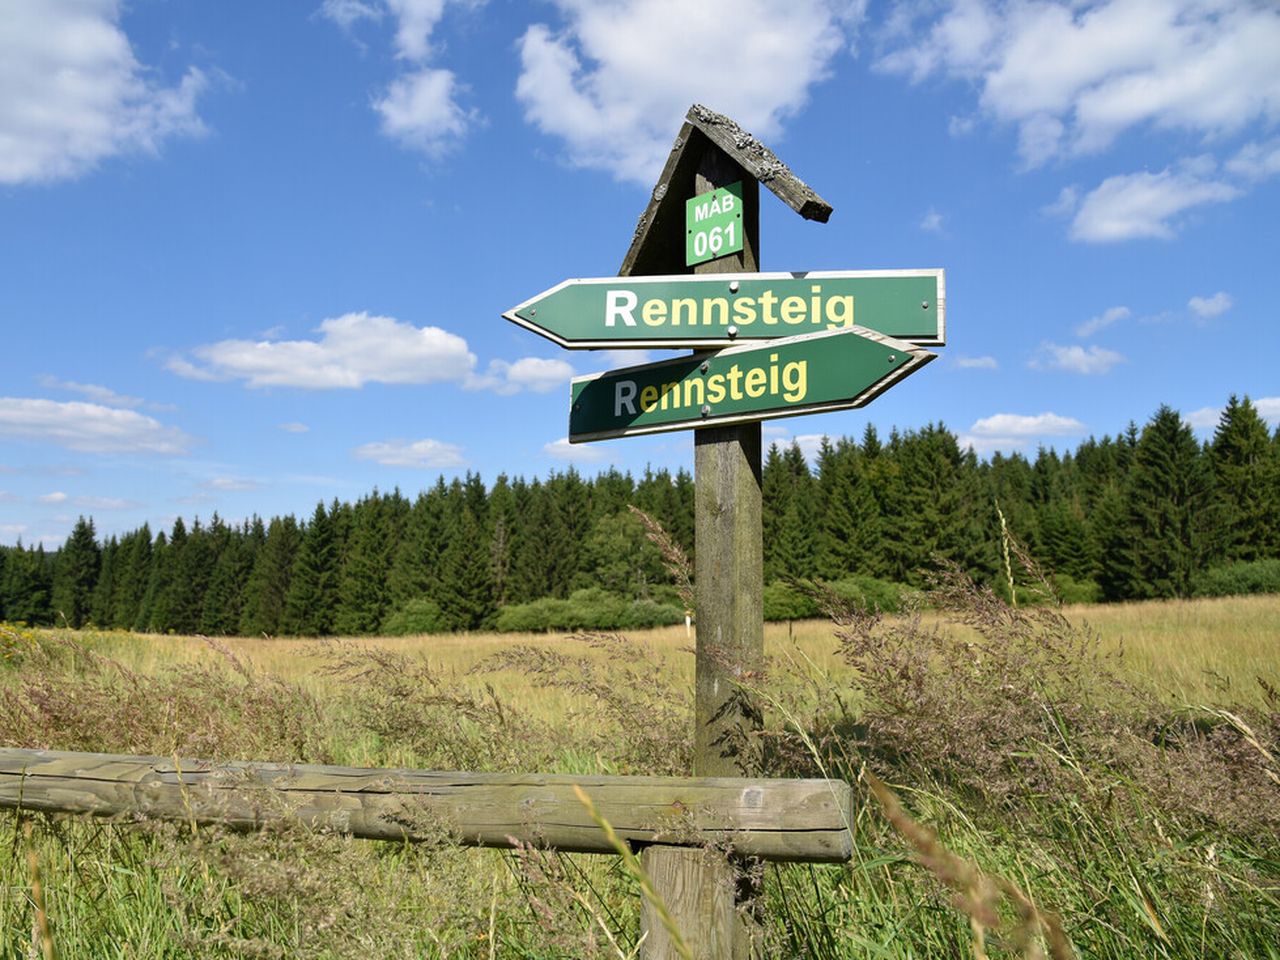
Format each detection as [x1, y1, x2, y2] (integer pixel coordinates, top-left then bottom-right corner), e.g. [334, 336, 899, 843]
[516, 0, 864, 186]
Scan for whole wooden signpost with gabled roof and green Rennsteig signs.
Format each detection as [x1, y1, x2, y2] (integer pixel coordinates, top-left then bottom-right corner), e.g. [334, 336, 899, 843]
[503, 105, 946, 960]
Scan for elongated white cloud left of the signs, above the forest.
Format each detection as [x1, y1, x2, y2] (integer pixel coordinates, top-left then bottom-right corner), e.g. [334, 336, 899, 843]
[166, 312, 476, 389]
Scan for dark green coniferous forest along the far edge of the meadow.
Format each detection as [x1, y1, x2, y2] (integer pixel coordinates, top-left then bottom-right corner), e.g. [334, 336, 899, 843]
[0, 397, 1280, 636]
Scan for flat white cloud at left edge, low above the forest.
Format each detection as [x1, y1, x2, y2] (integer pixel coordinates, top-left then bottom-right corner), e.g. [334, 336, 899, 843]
[0, 397, 192, 454]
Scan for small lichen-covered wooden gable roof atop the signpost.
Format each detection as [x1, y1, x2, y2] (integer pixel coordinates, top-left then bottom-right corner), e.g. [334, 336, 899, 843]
[618, 104, 831, 276]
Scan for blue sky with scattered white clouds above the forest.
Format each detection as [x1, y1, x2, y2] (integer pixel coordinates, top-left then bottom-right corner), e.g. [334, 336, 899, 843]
[0, 0, 1280, 544]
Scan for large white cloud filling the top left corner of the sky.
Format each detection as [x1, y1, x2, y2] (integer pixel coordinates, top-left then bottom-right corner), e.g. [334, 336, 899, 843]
[0, 0, 206, 183]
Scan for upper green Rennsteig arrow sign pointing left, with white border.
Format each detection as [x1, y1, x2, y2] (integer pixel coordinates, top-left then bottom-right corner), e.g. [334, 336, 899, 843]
[503, 270, 946, 349]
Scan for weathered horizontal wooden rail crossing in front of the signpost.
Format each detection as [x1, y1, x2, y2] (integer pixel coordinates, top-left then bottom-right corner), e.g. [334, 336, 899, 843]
[0, 749, 851, 863]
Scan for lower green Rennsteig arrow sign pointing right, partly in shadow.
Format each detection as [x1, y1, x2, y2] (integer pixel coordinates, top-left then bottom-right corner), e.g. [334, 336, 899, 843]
[568, 326, 936, 443]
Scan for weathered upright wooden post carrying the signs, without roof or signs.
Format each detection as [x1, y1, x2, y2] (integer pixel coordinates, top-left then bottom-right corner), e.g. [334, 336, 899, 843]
[640, 142, 764, 960]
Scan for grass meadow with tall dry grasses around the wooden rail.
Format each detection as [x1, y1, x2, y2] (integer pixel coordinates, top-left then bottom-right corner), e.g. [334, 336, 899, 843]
[0, 583, 1280, 960]
